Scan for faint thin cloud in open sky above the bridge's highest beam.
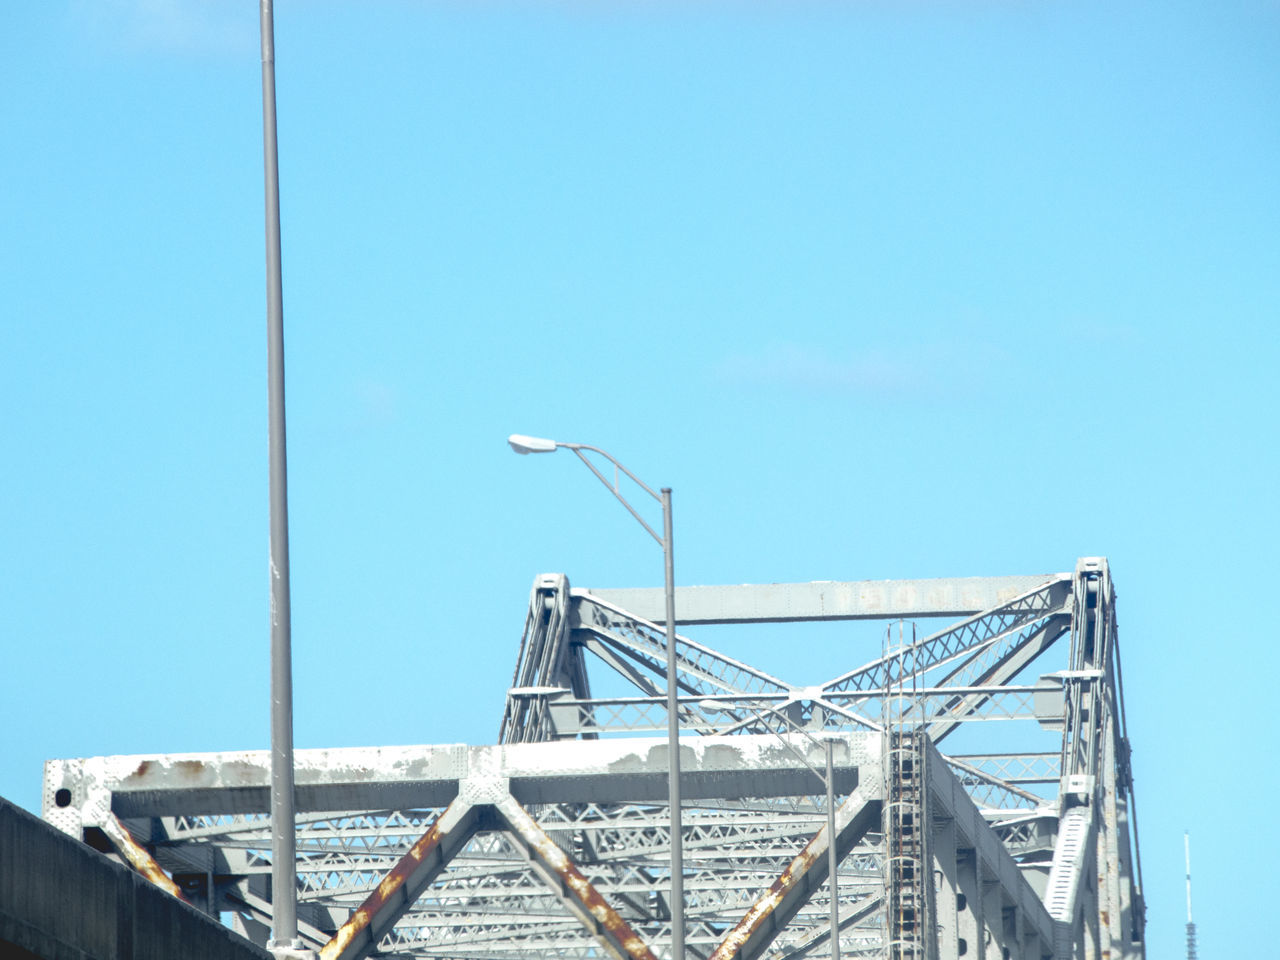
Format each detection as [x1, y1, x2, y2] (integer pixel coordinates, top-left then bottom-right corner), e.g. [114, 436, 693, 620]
[717, 342, 1006, 397]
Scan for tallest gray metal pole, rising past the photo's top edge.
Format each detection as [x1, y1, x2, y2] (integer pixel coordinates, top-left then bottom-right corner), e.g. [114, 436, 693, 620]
[260, 0, 302, 948]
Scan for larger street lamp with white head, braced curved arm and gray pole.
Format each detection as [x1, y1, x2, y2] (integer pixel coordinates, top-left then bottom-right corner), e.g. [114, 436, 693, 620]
[507, 434, 685, 960]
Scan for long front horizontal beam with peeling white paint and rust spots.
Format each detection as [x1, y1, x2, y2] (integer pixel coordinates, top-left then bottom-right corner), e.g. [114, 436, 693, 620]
[45, 732, 881, 832]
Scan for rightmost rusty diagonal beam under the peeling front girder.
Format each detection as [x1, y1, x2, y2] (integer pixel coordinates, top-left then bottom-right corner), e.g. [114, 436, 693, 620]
[708, 777, 882, 960]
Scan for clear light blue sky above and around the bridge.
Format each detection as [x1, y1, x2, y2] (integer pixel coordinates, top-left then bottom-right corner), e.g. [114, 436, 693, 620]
[0, 0, 1280, 960]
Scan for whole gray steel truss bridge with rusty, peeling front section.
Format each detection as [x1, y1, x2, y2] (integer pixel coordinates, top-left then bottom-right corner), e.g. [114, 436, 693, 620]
[44, 558, 1144, 960]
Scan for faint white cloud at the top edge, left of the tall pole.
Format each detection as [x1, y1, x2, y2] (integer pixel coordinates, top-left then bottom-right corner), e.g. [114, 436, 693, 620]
[70, 0, 259, 55]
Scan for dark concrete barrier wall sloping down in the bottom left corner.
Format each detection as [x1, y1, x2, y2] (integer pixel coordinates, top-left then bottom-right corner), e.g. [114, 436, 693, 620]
[0, 799, 271, 960]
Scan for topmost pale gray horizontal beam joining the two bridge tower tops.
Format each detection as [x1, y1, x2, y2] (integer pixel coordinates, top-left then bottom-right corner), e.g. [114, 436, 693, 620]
[586, 573, 1071, 623]
